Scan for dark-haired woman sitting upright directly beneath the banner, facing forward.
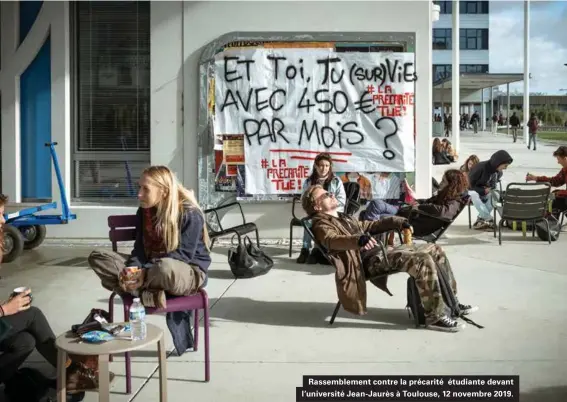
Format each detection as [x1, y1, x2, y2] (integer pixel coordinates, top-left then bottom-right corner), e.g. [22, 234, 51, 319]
[296, 152, 346, 264]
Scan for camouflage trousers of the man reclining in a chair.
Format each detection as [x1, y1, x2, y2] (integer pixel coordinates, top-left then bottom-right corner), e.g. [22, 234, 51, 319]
[365, 244, 457, 324]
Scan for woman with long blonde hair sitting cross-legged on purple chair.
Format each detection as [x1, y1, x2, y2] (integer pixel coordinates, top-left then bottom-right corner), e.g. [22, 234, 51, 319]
[89, 166, 211, 308]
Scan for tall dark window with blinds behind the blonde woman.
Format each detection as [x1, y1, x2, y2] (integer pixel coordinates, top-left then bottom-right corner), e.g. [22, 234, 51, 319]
[73, 1, 150, 201]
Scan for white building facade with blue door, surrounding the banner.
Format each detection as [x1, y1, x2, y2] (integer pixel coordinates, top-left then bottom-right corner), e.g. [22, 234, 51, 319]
[0, 1, 432, 239]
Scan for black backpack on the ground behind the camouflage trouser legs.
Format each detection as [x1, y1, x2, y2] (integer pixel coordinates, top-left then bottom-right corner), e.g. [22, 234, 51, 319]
[406, 265, 484, 328]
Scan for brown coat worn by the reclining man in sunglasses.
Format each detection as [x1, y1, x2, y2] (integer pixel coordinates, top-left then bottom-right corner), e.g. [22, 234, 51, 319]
[312, 213, 407, 315]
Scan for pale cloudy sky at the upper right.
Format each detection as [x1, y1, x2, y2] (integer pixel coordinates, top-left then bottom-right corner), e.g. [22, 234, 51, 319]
[489, 0, 567, 95]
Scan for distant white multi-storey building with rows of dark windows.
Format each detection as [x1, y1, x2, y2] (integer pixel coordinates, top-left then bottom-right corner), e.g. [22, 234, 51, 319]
[433, 1, 490, 113]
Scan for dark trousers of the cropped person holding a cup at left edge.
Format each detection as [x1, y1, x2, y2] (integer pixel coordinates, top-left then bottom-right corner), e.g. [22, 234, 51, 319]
[0, 307, 57, 383]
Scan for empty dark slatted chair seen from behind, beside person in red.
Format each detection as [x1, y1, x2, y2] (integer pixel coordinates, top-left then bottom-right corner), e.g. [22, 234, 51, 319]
[494, 183, 551, 245]
